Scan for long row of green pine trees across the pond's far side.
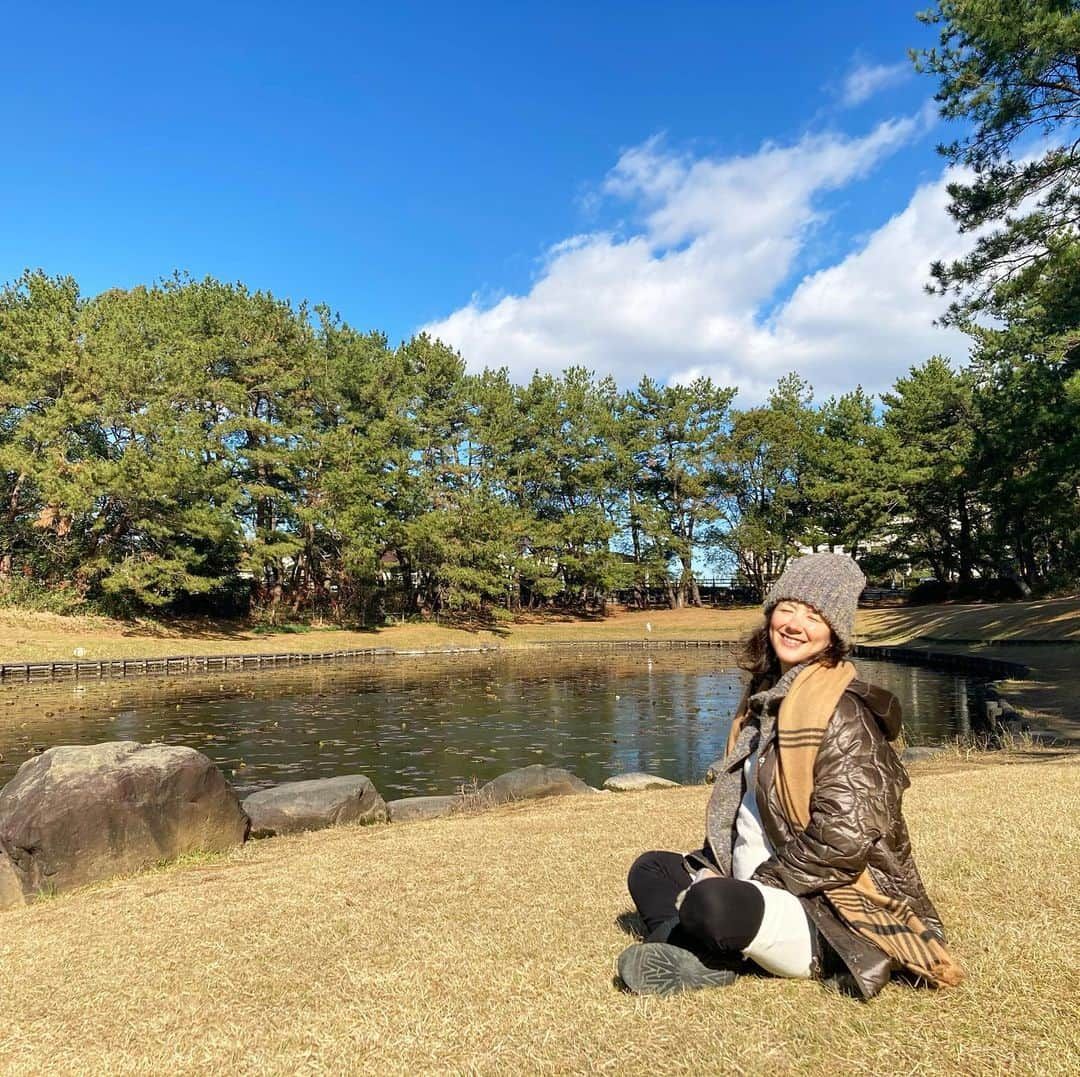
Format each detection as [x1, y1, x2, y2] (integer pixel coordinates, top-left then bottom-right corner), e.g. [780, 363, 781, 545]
[0, 241, 1080, 613]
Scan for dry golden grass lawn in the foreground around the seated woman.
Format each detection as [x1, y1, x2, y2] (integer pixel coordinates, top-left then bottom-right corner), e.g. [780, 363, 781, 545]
[0, 757, 1080, 1074]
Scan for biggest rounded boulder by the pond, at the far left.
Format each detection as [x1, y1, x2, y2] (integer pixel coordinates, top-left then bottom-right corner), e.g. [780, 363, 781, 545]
[0, 741, 248, 897]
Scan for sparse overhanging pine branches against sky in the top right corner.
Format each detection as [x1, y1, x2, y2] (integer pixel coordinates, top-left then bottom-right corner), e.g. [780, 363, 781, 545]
[915, 0, 1080, 323]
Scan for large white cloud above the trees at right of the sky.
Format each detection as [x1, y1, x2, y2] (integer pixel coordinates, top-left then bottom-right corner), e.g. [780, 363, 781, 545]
[424, 117, 970, 404]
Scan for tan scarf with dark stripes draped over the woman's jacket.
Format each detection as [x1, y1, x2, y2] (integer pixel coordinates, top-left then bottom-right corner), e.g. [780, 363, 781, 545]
[729, 662, 963, 987]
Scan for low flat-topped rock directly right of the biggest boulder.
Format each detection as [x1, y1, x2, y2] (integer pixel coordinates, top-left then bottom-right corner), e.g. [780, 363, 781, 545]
[244, 775, 387, 837]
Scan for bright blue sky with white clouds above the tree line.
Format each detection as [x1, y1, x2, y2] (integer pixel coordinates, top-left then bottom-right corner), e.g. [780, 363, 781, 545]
[0, 0, 962, 402]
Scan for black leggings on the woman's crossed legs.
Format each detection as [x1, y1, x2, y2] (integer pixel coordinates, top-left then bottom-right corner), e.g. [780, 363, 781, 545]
[626, 850, 765, 953]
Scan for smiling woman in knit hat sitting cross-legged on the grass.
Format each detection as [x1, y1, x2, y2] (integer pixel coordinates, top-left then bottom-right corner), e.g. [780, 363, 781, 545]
[619, 553, 961, 998]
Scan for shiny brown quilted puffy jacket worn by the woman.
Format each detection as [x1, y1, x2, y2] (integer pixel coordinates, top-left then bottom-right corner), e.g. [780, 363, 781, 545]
[710, 681, 945, 998]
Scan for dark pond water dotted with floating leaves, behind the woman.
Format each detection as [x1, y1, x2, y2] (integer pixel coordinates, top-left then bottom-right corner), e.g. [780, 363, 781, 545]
[0, 648, 981, 799]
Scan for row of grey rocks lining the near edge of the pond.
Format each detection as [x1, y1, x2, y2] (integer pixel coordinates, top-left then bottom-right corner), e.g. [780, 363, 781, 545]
[0, 741, 675, 908]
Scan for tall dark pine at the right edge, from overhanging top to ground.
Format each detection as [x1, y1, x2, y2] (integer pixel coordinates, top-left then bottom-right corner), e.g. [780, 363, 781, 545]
[913, 0, 1080, 587]
